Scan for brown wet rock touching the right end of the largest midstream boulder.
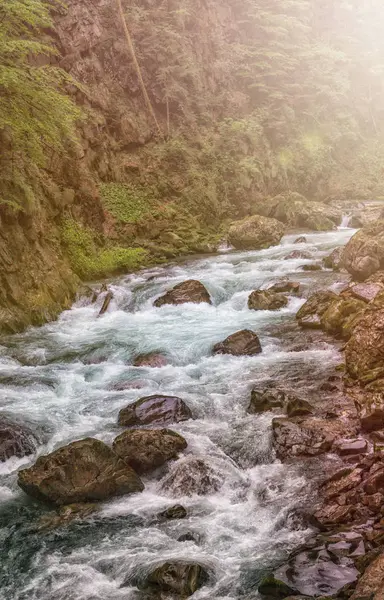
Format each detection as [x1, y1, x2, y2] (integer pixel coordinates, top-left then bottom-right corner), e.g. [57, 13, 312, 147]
[112, 429, 187, 475]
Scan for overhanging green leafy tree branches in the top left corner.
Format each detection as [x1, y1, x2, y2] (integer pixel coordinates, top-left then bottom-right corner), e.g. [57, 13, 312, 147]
[0, 0, 81, 210]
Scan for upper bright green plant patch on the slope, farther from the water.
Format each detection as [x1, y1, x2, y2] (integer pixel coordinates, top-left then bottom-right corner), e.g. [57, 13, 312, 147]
[100, 183, 154, 223]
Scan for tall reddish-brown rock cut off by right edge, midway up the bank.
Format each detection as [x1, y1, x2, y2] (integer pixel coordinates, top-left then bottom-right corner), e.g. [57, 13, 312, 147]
[345, 292, 384, 384]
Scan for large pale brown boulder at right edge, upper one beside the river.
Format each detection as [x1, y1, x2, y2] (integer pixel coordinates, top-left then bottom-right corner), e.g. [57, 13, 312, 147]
[342, 220, 384, 281]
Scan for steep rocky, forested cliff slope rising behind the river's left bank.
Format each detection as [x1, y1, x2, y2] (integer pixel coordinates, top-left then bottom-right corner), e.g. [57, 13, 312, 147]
[0, 0, 382, 331]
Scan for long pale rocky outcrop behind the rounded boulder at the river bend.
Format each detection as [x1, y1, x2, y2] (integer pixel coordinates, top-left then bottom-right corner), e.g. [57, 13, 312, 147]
[252, 192, 342, 231]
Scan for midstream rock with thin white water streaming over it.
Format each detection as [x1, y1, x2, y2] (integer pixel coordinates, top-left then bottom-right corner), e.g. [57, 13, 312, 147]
[161, 456, 223, 497]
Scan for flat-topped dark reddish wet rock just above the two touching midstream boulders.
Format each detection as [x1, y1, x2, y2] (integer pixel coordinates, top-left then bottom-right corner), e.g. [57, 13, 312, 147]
[118, 394, 192, 427]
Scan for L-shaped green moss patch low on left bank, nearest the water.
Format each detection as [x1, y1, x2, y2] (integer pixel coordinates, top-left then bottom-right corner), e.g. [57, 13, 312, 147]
[61, 219, 147, 279]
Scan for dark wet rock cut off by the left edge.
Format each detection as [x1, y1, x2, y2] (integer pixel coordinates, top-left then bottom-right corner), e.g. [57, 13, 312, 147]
[0, 417, 37, 462]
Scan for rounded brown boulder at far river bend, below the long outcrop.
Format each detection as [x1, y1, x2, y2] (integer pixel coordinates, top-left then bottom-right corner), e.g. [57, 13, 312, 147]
[228, 215, 285, 250]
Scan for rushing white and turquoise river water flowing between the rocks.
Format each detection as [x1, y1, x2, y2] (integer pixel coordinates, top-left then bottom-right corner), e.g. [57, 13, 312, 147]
[0, 228, 353, 600]
